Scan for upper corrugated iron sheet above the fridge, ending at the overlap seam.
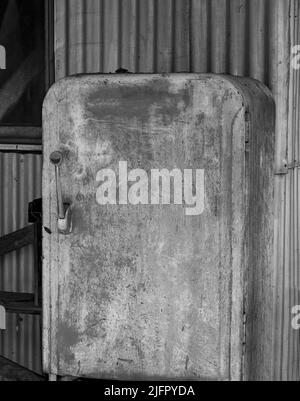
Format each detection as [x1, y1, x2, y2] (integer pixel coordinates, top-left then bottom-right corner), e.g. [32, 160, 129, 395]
[55, 0, 292, 166]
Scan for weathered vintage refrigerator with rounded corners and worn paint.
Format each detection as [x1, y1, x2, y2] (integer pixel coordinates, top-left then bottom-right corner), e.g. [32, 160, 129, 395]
[43, 74, 275, 380]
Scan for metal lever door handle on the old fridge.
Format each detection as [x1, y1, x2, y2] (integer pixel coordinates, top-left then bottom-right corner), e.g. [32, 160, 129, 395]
[50, 151, 72, 235]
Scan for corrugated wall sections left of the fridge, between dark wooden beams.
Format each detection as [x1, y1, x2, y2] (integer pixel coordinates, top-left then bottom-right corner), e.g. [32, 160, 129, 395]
[0, 152, 42, 372]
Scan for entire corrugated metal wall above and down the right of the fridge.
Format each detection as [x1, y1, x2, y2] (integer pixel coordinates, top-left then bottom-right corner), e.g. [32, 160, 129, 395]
[54, 0, 300, 380]
